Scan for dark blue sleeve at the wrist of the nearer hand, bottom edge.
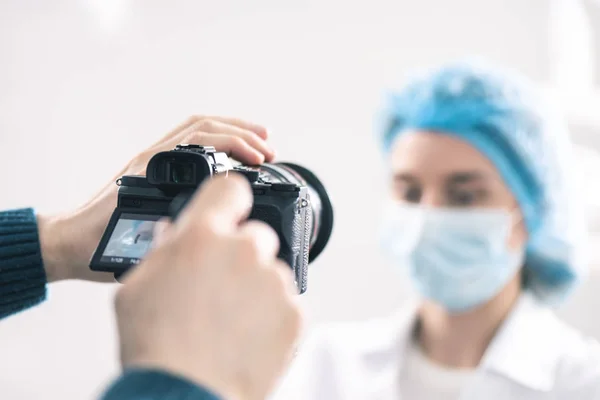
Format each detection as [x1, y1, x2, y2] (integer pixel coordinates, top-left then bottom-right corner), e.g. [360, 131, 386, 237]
[102, 369, 223, 400]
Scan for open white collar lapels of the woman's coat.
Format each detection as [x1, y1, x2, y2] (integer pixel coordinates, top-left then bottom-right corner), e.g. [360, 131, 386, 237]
[356, 293, 561, 392]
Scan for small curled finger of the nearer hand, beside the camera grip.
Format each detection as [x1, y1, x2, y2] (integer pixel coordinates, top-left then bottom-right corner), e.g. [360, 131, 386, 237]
[238, 220, 279, 265]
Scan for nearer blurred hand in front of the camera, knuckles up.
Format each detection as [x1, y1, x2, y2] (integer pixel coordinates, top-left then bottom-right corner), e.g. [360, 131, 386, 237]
[116, 176, 301, 400]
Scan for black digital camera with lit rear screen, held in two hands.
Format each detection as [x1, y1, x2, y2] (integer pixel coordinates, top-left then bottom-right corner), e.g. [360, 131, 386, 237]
[90, 144, 333, 293]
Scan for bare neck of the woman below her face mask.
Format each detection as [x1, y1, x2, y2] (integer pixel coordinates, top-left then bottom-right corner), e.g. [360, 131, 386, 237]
[417, 281, 521, 369]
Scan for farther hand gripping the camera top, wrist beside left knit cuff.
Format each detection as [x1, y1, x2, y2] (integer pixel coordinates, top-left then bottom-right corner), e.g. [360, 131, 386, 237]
[38, 116, 275, 282]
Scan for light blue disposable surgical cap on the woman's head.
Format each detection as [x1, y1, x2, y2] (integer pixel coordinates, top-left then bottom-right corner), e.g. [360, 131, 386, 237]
[380, 61, 588, 306]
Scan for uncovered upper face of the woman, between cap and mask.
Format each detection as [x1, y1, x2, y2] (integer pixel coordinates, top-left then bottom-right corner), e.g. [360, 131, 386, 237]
[390, 131, 527, 249]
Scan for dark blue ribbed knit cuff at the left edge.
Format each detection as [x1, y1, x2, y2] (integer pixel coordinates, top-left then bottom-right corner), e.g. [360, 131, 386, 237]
[0, 208, 46, 318]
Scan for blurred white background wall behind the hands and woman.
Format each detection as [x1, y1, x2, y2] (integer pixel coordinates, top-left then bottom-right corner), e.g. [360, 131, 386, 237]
[0, 0, 600, 400]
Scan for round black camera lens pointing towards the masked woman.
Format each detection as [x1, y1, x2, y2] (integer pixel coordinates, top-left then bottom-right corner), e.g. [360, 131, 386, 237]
[260, 163, 333, 262]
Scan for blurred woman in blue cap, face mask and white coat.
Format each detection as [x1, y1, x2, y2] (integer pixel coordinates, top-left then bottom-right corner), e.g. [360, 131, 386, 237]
[275, 63, 600, 400]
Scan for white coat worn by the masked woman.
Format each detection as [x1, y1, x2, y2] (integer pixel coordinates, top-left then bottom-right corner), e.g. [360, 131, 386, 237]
[271, 295, 600, 400]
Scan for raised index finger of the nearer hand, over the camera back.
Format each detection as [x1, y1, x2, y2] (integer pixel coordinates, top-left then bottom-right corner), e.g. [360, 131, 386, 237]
[176, 174, 252, 231]
